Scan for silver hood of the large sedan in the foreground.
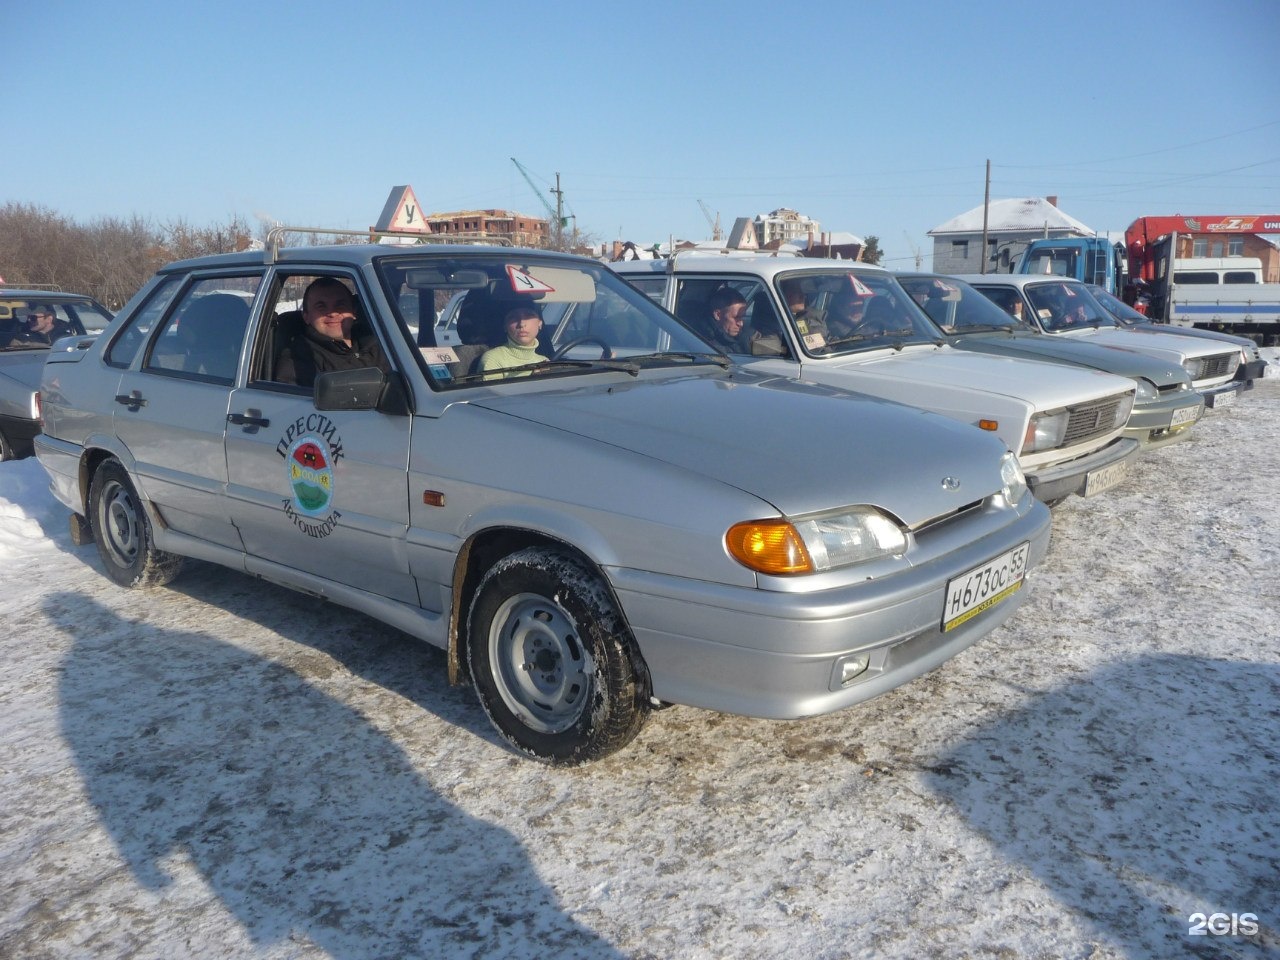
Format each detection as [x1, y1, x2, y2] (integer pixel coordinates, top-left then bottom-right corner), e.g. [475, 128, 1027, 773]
[470, 371, 1005, 525]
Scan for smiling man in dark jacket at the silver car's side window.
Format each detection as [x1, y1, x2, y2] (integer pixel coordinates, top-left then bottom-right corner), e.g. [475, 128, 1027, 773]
[274, 276, 390, 387]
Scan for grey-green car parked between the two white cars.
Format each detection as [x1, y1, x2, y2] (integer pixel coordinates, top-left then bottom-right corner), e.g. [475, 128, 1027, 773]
[897, 273, 1204, 449]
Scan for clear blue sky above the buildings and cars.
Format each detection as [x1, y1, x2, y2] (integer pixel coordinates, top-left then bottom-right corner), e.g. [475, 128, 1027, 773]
[0, 0, 1280, 266]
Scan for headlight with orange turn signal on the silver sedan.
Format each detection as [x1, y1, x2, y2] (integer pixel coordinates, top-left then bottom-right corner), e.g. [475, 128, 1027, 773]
[724, 507, 906, 573]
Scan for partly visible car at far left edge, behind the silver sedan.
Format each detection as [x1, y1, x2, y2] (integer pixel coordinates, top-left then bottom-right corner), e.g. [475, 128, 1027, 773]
[0, 288, 111, 461]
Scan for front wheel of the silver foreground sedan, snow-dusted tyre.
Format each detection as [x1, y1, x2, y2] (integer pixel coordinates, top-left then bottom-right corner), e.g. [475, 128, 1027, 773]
[467, 548, 649, 765]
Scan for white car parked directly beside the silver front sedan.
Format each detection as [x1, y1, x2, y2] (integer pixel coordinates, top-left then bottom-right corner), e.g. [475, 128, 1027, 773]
[611, 251, 1138, 504]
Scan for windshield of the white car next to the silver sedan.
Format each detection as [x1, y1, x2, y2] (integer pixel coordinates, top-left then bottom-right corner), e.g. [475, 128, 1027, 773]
[778, 270, 942, 357]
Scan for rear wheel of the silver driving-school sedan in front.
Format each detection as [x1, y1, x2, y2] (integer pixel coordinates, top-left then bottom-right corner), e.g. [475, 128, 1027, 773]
[88, 458, 183, 586]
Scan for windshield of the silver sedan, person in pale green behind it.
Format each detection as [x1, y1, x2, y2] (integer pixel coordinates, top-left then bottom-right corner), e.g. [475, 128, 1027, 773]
[378, 257, 727, 388]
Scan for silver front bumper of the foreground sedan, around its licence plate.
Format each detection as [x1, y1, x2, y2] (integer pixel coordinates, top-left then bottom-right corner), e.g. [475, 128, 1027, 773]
[607, 503, 1050, 719]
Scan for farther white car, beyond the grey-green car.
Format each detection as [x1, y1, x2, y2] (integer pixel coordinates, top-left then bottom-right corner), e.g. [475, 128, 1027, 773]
[959, 274, 1240, 408]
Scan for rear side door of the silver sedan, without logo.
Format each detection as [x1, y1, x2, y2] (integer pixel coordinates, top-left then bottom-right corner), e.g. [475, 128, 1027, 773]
[110, 274, 261, 549]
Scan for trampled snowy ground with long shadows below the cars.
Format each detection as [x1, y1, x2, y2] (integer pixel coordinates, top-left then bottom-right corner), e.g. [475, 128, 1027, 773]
[0, 358, 1280, 960]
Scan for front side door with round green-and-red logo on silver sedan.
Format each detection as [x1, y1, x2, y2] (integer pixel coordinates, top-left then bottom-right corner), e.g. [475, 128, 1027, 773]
[227, 270, 417, 604]
